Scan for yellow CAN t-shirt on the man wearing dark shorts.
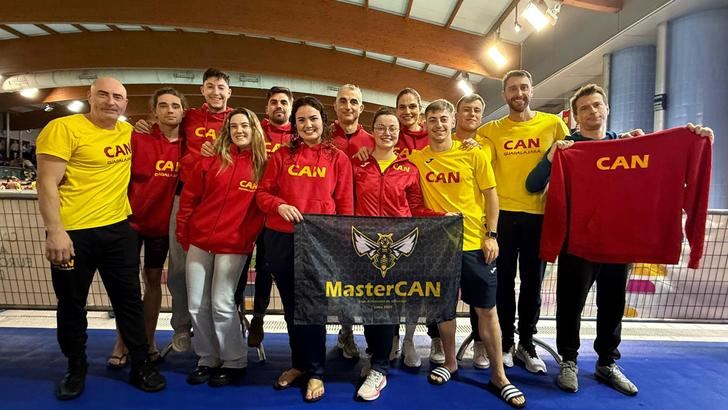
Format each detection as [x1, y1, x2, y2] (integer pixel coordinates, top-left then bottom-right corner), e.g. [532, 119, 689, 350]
[409, 141, 495, 251]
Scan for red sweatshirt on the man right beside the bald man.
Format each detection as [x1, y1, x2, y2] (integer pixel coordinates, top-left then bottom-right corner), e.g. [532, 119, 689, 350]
[129, 124, 181, 238]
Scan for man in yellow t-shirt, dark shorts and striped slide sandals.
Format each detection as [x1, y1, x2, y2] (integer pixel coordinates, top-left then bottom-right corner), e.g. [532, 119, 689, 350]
[409, 100, 525, 406]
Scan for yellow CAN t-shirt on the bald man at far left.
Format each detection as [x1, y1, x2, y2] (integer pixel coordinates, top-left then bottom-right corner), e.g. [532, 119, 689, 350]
[36, 114, 132, 231]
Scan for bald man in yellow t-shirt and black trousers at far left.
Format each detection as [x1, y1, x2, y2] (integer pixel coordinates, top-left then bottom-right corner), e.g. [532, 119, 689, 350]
[36, 77, 166, 400]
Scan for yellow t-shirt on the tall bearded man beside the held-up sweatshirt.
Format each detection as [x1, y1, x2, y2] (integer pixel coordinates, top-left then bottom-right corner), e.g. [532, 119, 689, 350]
[476, 111, 569, 214]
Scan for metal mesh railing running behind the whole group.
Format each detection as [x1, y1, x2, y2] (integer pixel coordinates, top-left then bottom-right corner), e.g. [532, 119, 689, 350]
[0, 192, 728, 323]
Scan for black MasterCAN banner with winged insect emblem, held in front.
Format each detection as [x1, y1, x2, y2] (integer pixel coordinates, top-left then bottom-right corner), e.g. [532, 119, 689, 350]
[294, 215, 463, 324]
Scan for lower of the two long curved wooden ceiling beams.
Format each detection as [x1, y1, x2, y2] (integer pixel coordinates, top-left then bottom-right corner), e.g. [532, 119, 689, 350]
[0, 31, 457, 100]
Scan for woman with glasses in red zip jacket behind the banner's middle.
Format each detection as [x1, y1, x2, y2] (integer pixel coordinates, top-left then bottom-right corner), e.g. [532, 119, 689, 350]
[352, 107, 444, 400]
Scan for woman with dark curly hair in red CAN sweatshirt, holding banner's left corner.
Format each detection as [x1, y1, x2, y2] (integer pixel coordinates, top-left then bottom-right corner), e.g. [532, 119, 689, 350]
[257, 96, 354, 402]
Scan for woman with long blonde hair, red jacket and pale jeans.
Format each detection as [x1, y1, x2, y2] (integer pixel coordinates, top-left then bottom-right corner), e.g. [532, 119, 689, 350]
[177, 108, 266, 386]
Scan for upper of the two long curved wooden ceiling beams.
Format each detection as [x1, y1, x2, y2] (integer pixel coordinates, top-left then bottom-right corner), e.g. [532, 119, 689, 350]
[0, 0, 520, 77]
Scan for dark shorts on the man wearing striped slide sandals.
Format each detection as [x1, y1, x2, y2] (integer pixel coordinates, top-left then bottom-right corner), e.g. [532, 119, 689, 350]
[460, 250, 498, 308]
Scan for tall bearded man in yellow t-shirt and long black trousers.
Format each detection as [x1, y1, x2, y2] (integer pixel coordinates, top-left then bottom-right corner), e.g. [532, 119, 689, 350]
[476, 70, 569, 373]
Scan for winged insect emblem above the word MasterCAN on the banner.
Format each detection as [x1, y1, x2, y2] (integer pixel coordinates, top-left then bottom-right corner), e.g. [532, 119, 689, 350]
[351, 226, 419, 277]
